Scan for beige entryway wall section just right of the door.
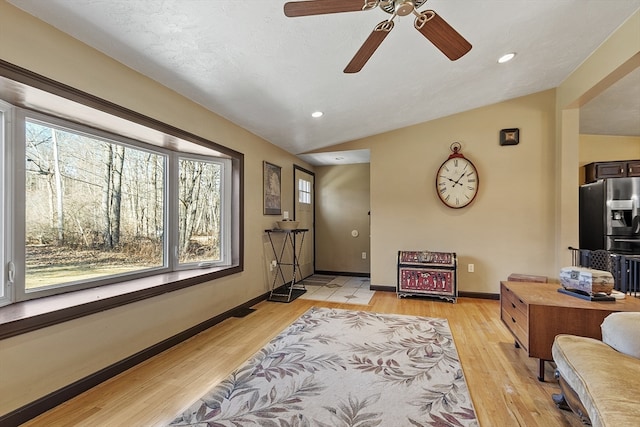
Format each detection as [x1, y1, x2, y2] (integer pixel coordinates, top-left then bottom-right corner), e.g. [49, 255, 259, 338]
[315, 164, 370, 273]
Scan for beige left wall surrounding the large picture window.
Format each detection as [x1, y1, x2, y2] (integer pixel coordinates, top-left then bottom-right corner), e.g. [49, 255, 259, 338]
[0, 0, 313, 415]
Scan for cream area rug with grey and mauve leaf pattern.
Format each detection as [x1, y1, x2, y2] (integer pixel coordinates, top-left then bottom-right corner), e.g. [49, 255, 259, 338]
[170, 307, 478, 427]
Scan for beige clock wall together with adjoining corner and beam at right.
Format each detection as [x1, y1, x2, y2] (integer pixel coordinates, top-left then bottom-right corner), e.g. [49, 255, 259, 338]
[312, 11, 640, 293]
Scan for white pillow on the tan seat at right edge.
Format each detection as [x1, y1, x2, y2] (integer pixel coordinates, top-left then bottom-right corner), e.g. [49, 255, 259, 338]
[601, 312, 640, 359]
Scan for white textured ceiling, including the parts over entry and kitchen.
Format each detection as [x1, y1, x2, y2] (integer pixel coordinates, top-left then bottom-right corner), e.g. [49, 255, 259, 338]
[8, 0, 640, 164]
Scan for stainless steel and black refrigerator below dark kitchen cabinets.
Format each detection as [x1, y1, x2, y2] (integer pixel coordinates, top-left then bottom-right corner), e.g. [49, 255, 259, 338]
[579, 178, 640, 254]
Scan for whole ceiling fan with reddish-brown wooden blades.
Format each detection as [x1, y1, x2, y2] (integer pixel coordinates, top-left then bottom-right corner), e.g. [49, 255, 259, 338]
[284, 0, 471, 73]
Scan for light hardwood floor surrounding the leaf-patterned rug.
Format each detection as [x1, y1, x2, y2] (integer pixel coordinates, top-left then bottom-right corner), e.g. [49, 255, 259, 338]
[25, 292, 581, 427]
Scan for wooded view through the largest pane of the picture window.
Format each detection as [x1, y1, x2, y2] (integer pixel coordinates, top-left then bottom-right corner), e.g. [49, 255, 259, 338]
[25, 121, 166, 289]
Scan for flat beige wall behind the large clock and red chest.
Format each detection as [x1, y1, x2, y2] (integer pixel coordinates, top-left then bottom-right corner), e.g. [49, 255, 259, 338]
[318, 90, 556, 293]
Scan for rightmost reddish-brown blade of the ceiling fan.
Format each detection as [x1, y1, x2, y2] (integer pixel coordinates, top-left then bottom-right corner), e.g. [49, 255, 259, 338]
[414, 10, 471, 61]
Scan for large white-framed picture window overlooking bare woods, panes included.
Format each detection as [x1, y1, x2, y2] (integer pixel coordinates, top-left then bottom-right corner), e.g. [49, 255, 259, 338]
[0, 98, 238, 304]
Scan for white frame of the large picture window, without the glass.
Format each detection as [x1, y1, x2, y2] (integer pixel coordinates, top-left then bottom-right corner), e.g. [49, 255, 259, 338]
[5, 103, 233, 305]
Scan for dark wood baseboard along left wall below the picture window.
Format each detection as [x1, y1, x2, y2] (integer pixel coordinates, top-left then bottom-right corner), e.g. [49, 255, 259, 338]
[0, 292, 269, 427]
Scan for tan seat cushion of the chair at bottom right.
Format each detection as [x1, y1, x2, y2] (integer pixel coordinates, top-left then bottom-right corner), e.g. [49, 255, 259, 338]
[552, 335, 640, 427]
